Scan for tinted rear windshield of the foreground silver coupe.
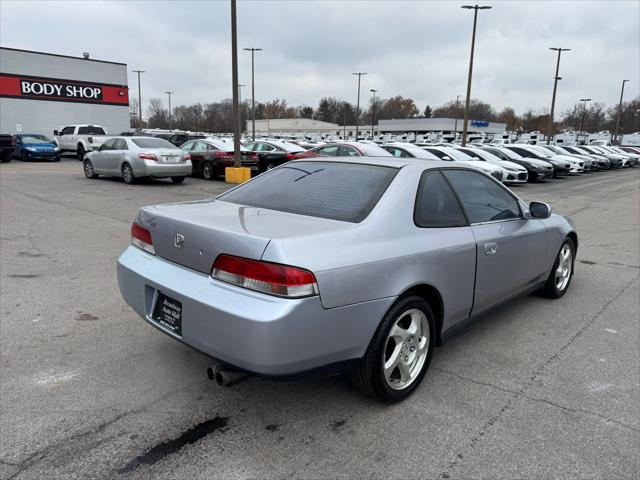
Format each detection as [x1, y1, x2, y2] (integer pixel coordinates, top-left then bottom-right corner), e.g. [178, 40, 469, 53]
[218, 162, 398, 223]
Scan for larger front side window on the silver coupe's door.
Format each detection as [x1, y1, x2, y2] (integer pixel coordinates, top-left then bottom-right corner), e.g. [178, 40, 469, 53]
[443, 170, 521, 223]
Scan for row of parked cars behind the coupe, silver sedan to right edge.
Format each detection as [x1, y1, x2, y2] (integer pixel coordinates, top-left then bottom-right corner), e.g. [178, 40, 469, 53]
[84, 136, 640, 185]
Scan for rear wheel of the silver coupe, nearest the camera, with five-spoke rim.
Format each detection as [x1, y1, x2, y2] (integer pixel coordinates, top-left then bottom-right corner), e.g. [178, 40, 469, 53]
[351, 296, 435, 403]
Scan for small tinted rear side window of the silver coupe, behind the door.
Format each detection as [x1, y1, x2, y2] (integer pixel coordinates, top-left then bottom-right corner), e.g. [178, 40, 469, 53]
[413, 170, 467, 227]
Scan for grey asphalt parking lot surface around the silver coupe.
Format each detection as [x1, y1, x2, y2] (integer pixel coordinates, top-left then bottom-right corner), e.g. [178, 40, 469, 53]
[0, 158, 640, 479]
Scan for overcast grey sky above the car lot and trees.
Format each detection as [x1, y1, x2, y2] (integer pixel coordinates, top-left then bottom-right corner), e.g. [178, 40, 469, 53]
[0, 0, 640, 113]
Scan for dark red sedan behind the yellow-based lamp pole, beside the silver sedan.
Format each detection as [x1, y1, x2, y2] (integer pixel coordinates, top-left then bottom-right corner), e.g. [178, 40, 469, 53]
[180, 138, 259, 180]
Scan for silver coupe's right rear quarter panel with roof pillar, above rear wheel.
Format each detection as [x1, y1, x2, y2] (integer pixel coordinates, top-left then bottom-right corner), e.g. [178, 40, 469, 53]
[262, 169, 476, 328]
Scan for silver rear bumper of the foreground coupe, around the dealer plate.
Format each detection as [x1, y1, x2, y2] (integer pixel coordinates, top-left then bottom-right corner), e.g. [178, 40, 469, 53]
[118, 246, 395, 376]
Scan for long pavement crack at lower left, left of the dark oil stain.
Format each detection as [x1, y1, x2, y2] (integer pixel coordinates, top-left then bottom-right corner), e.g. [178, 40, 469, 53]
[0, 380, 205, 480]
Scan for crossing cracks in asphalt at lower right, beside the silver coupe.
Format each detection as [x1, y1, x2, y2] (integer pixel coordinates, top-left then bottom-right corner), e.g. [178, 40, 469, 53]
[441, 275, 640, 478]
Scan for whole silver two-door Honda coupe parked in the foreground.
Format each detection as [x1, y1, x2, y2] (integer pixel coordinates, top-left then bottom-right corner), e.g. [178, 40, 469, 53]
[118, 157, 578, 402]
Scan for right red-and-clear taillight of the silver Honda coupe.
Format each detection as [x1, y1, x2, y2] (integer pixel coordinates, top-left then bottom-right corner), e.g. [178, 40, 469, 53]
[211, 255, 318, 298]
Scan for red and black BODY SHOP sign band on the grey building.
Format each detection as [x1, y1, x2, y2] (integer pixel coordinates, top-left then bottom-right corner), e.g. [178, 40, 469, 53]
[0, 73, 129, 105]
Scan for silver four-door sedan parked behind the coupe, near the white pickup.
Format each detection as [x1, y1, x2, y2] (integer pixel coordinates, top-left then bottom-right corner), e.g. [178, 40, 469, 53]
[83, 137, 192, 184]
